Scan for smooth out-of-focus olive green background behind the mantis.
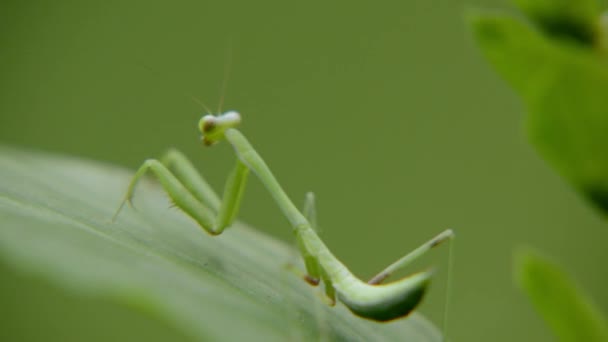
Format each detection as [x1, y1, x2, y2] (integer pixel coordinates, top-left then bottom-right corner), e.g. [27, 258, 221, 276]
[0, 0, 608, 341]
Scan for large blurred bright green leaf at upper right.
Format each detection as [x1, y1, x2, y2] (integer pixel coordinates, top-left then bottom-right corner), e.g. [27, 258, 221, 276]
[470, 13, 608, 213]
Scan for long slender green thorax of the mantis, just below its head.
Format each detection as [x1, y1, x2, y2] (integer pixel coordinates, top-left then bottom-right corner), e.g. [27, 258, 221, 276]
[225, 128, 310, 229]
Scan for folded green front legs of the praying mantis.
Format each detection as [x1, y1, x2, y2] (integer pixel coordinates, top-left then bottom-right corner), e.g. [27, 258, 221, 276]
[112, 150, 249, 235]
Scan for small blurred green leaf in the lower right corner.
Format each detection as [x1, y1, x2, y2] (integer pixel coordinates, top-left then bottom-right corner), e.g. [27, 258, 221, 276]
[515, 250, 608, 342]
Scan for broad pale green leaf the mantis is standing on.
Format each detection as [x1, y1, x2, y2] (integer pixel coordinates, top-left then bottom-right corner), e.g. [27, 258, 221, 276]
[0, 147, 441, 341]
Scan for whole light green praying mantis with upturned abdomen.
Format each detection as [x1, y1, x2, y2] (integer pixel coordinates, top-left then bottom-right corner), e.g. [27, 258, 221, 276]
[114, 111, 454, 321]
